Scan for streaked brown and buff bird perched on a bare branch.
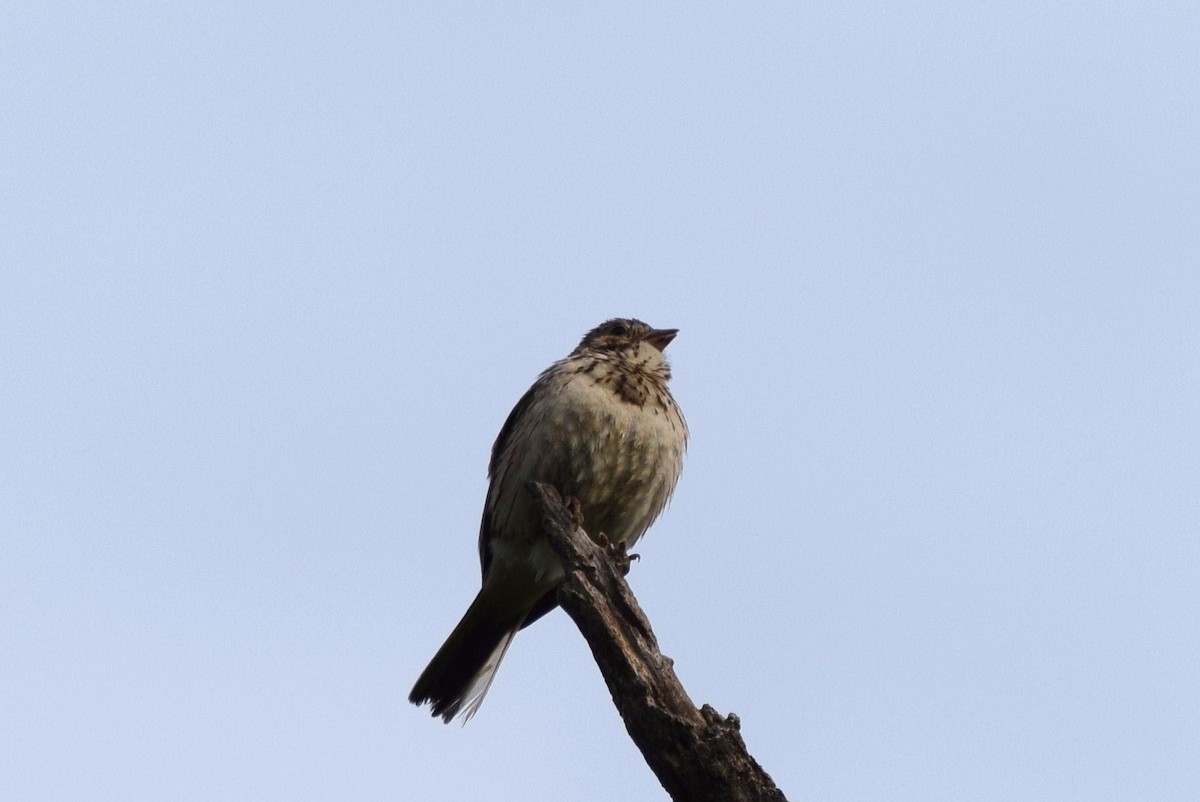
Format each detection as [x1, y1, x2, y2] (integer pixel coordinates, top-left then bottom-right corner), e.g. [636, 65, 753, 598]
[408, 318, 688, 724]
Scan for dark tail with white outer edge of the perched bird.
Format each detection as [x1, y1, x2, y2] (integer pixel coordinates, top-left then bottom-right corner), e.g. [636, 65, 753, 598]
[408, 585, 528, 724]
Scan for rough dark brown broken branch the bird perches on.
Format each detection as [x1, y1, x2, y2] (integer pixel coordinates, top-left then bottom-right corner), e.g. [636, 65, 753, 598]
[529, 483, 787, 802]
